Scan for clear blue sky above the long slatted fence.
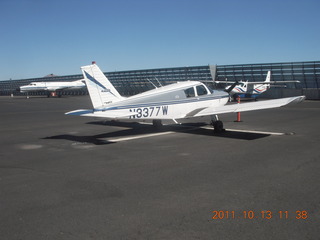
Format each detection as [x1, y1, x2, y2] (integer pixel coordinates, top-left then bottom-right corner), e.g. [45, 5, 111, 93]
[0, 0, 320, 80]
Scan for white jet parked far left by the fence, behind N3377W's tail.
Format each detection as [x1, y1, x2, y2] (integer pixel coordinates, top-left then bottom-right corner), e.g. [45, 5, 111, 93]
[17, 79, 86, 97]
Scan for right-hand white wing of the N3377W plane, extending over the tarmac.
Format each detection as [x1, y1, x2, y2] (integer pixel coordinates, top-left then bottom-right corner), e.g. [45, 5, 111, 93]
[190, 96, 306, 117]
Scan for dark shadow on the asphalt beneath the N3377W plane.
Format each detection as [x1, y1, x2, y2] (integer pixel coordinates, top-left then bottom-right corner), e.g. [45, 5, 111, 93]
[42, 122, 270, 145]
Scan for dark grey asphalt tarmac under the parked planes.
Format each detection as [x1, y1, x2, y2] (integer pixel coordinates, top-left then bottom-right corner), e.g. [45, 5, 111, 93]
[0, 96, 320, 240]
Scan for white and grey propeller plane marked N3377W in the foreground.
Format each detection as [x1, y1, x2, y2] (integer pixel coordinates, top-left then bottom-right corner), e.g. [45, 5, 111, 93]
[65, 63, 305, 133]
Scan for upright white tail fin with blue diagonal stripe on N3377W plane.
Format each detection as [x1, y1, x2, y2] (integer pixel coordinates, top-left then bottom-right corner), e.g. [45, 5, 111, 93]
[81, 64, 123, 108]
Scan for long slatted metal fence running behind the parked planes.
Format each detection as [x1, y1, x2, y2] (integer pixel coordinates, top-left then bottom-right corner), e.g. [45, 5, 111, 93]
[0, 61, 320, 99]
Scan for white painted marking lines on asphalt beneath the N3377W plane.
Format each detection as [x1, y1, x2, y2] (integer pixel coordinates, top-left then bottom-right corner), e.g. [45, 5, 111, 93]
[107, 127, 285, 142]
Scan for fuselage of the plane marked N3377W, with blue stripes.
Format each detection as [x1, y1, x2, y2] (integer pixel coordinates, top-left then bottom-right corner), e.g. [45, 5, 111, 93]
[94, 81, 229, 119]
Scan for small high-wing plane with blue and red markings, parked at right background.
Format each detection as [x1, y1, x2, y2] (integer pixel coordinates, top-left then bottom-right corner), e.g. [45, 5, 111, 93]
[215, 71, 300, 100]
